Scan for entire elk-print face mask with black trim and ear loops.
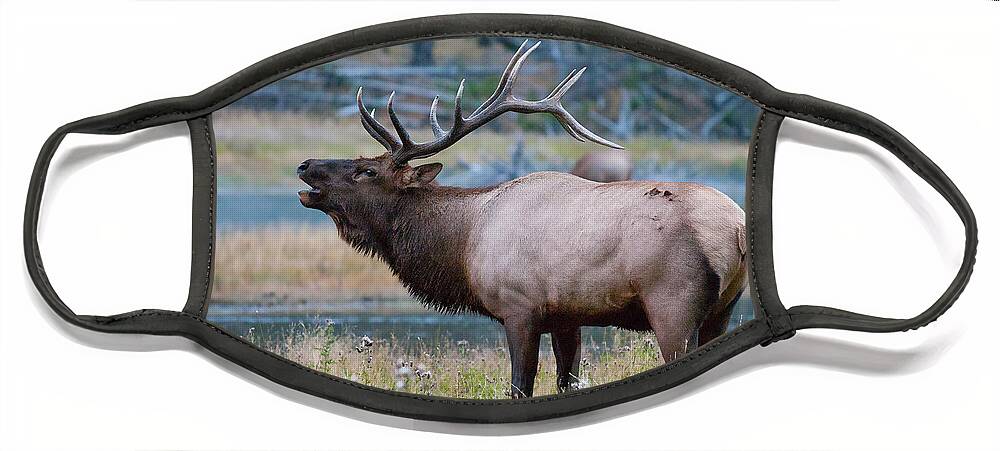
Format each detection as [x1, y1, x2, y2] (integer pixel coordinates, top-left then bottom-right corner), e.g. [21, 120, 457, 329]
[24, 14, 976, 422]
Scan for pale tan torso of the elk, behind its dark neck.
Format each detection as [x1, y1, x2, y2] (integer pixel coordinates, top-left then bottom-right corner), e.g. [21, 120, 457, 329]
[465, 172, 745, 326]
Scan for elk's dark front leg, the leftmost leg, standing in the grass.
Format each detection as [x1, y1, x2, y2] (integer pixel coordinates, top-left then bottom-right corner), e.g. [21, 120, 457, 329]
[503, 318, 541, 399]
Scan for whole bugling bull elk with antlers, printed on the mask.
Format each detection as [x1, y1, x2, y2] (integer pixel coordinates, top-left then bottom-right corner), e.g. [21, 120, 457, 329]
[297, 41, 746, 398]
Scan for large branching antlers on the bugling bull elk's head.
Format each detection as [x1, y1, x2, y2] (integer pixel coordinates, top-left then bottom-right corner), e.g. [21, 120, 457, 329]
[358, 41, 623, 165]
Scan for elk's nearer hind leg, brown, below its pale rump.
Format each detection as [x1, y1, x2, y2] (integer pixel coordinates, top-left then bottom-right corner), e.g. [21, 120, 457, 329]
[642, 276, 719, 362]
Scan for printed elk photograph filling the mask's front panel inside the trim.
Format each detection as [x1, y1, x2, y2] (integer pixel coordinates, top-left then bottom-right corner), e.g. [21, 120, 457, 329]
[206, 37, 760, 399]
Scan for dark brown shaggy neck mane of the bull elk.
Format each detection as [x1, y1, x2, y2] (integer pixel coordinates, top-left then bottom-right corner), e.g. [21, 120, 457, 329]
[337, 186, 492, 316]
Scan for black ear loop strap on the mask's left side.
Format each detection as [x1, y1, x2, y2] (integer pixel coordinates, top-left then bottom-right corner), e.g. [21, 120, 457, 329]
[24, 110, 210, 335]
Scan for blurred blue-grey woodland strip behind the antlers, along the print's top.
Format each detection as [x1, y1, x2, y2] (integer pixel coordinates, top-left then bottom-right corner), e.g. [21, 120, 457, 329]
[232, 36, 758, 141]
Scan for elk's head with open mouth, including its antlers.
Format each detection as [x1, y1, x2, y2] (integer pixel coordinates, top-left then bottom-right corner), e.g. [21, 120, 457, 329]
[298, 41, 622, 229]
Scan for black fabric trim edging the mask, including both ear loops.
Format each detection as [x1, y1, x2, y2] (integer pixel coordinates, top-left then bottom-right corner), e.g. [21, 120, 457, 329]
[24, 14, 977, 423]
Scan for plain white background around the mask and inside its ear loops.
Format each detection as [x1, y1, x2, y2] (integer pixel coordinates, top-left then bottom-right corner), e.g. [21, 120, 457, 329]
[0, 0, 1000, 449]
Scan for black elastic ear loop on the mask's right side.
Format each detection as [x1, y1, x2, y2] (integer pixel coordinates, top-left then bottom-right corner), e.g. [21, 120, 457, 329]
[777, 103, 978, 332]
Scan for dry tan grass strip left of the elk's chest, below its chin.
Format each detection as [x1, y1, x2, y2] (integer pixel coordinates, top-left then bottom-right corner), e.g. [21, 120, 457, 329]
[212, 225, 408, 300]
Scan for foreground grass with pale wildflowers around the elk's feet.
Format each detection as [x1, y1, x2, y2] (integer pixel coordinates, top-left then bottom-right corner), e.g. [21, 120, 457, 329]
[244, 326, 663, 399]
